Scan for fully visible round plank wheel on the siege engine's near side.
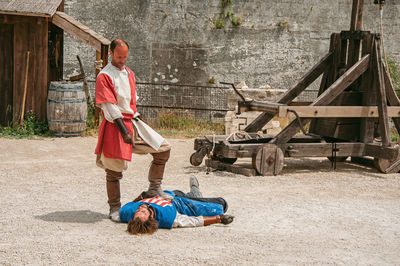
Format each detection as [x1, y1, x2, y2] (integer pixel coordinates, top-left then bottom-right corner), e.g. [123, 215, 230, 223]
[252, 144, 284, 175]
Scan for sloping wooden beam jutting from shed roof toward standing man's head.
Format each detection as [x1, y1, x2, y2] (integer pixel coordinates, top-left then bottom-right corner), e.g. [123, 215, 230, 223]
[51, 11, 111, 51]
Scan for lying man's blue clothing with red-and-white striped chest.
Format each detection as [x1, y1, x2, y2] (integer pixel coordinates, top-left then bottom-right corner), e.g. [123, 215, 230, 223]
[119, 190, 224, 228]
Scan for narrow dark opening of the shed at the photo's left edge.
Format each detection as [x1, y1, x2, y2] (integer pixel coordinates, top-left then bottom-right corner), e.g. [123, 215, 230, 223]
[0, 24, 14, 126]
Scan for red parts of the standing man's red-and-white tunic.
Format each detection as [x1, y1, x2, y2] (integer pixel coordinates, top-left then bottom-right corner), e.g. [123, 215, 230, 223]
[95, 66, 136, 161]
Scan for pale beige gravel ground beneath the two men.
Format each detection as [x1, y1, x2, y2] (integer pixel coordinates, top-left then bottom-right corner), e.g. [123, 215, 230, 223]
[0, 137, 400, 265]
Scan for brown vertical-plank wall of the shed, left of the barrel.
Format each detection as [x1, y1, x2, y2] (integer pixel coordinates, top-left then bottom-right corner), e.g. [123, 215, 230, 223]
[0, 15, 48, 123]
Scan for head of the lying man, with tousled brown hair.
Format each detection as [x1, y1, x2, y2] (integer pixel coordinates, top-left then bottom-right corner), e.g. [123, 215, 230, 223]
[127, 204, 158, 235]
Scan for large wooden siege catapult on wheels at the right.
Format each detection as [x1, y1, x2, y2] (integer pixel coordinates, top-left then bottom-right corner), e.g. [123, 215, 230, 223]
[191, 0, 400, 175]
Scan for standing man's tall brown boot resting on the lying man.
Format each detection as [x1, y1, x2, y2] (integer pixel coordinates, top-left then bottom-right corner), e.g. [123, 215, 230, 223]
[144, 150, 172, 199]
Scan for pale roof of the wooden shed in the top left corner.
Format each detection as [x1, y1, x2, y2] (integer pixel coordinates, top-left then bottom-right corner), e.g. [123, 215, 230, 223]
[0, 0, 62, 17]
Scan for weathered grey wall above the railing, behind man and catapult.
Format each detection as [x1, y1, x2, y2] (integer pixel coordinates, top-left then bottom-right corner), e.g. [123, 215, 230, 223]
[64, 0, 400, 89]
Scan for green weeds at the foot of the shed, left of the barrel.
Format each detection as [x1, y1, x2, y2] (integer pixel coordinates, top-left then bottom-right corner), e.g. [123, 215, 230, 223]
[0, 111, 53, 139]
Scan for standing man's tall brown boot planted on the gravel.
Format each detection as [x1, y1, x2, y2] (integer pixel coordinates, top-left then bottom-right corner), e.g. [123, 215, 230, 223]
[106, 169, 122, 222]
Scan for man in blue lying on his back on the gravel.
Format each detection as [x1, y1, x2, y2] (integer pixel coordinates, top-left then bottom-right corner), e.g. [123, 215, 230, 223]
[119, 177, 234, 235]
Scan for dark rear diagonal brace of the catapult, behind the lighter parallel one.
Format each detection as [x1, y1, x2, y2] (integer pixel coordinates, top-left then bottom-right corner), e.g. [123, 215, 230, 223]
[244, 52, 333, 132]
